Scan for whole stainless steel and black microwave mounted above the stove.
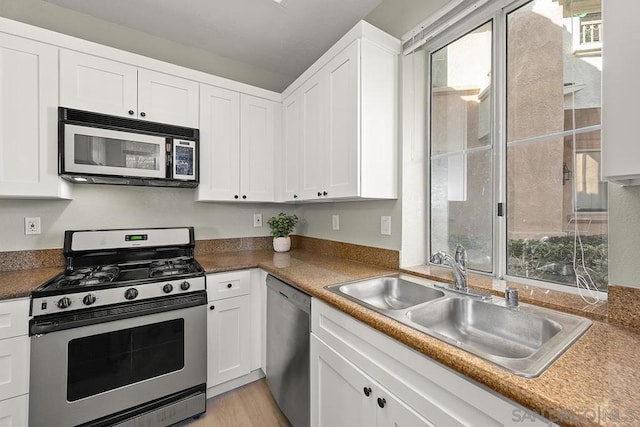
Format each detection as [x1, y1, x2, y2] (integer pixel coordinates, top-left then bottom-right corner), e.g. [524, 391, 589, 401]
[58, 107, 199, 188]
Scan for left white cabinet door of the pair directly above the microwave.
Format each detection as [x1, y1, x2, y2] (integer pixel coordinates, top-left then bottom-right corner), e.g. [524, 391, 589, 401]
[60, 49, 138, 118]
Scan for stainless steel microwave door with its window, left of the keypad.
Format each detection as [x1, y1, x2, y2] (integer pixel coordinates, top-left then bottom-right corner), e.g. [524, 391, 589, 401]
[62, 124, 167, 178]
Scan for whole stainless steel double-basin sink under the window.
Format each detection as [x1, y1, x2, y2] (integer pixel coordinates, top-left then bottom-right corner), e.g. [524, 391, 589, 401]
[327, 275, 592, 377]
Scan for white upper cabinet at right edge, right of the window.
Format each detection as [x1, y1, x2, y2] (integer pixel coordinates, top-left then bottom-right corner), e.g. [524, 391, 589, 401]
[602, 1, 640, 185]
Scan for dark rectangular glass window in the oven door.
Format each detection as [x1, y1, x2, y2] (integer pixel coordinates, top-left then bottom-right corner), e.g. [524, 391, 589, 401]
[67, 319, 184, 402]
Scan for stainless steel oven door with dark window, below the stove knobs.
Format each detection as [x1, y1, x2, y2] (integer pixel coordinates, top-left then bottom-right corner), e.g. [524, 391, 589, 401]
[29, 298, 207, 427]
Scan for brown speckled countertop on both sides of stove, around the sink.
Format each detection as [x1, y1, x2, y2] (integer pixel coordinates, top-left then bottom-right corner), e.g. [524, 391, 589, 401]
[0, 250, 640, 426]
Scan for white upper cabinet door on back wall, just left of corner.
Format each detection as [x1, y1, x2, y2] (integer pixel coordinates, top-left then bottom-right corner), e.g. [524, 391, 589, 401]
[240, 94, 279, 202]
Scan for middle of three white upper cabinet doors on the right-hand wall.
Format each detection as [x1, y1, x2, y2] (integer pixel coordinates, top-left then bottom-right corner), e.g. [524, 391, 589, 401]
[300, 72, 326, 200]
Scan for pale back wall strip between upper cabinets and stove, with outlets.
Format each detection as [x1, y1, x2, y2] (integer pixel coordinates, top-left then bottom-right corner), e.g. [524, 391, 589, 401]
[0, 184, 284, 251]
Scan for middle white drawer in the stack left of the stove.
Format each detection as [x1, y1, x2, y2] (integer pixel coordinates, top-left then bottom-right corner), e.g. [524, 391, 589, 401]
[0, 335, 29, 400]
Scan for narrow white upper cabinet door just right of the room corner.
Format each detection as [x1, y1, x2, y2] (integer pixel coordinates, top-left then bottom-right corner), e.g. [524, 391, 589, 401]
[277, 91, 301, 201]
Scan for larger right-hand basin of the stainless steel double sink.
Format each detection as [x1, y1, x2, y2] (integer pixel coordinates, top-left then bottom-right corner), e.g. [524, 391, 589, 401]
[407, 298, 562, 358]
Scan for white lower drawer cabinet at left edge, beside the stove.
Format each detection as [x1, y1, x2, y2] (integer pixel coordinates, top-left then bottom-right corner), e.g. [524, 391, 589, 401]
[0, 298, 30, 427]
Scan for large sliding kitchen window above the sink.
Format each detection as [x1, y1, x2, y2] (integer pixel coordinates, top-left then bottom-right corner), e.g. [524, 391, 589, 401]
[418, 0, 608, 296]
